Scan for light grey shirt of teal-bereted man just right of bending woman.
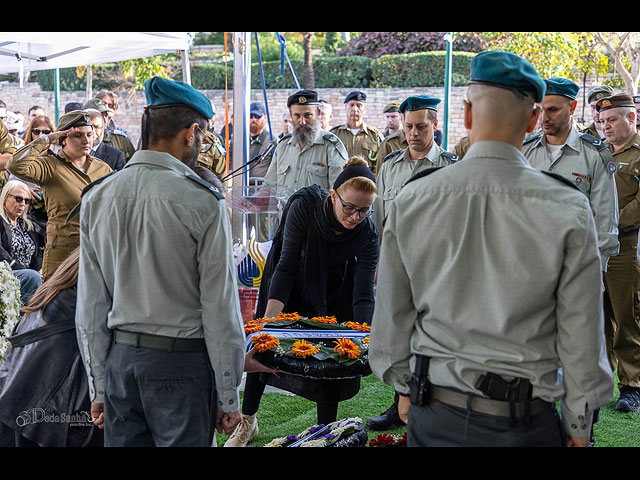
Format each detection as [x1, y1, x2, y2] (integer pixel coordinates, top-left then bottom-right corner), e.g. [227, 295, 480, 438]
[371, 141, 457, 233]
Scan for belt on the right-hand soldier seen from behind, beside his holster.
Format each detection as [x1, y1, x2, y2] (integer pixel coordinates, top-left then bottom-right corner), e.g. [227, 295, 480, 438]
[429, 384, 552, 418]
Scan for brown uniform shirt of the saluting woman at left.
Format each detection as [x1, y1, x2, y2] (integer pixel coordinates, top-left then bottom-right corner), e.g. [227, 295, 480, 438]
[7, 137, 112, 246]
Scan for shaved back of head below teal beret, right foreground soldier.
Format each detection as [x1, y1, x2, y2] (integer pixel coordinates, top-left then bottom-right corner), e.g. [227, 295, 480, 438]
[465, 84, 540, 148]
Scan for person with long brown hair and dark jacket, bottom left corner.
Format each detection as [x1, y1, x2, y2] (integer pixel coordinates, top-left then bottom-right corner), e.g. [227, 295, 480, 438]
[0, 248, 104, 447]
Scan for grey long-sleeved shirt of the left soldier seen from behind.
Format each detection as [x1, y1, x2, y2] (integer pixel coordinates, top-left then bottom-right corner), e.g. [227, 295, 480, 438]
[76, 150, 245, 412]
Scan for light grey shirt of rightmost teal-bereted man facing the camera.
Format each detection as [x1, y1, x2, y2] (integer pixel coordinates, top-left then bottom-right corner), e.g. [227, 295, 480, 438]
[522, 127, 620, 272]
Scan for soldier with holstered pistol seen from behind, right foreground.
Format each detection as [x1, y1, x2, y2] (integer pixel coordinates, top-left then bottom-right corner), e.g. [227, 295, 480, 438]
[369, 50, 613, 447]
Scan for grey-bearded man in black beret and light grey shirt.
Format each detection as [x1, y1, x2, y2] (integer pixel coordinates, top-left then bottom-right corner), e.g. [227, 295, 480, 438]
[264, 90, 347, 191]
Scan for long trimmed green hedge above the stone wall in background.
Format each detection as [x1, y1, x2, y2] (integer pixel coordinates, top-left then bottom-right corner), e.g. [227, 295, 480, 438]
[35, 52, 475, 90]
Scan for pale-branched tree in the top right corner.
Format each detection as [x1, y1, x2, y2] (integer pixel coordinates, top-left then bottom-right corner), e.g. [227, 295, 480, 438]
[594, 32, 640, 95]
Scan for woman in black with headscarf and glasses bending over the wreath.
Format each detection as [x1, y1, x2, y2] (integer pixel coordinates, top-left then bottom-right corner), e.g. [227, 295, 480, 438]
[225, 157, 378, 447]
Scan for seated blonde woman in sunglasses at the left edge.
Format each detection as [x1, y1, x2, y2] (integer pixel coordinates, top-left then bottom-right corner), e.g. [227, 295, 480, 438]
[0, 180, 43, 304]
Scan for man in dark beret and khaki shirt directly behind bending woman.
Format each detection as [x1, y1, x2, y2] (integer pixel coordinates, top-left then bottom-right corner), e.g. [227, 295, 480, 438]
[331, 91, 384, 171]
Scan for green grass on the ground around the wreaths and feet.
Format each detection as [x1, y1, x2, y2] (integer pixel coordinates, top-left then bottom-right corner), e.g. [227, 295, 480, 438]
[216, 375, 640, 447]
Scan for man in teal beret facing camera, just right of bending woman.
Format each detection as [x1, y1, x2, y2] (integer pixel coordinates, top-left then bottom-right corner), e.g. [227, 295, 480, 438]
[372, 95, 458, 237]
